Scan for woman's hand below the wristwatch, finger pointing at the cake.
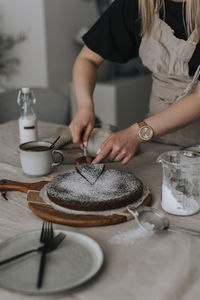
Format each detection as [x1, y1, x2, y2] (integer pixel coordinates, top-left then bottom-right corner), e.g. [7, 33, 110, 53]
[92, 124, 141, 164]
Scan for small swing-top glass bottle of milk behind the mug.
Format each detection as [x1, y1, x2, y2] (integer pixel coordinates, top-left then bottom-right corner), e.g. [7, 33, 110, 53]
[17, 88, 37, 144]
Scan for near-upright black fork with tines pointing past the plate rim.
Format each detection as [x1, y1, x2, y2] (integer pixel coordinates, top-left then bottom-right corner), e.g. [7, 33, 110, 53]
[37, 221, 54, 288]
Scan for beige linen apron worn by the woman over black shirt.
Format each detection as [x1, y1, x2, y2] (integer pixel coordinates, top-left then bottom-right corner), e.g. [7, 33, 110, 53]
[139, 14, 200, 146]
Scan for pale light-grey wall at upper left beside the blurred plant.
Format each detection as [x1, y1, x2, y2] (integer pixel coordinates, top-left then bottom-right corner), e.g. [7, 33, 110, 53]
[0, 0, 48, 87]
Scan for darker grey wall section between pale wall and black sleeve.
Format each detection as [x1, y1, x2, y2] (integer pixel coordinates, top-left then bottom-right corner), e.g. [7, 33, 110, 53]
[44, 0, 98, 94]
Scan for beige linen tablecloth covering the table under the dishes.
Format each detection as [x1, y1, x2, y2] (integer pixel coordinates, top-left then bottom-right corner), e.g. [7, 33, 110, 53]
[0, 121, 200, 300]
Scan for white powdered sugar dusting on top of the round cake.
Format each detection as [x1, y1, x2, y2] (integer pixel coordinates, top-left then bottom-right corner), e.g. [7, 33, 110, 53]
[46, 169, 142, 202]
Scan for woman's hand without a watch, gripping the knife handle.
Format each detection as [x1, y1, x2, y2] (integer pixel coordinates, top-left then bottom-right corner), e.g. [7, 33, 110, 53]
[69, 103, 95, 144]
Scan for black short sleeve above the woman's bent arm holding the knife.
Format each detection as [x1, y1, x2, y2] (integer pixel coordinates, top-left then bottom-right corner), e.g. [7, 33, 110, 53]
[83, 0, 139, 63]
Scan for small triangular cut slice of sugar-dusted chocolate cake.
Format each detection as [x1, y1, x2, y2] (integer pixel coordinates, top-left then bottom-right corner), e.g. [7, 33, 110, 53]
[76, 164, 105, 184]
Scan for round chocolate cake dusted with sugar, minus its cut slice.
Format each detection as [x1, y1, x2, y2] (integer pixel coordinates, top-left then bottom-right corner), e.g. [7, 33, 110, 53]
[46, 169, 143, 211]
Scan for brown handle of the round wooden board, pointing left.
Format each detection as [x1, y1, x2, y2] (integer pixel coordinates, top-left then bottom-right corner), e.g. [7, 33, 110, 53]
[0, 179, 48, 193]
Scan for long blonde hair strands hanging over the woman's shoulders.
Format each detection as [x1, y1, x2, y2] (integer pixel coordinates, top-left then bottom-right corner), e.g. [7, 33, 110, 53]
[138, 0, 200, 41]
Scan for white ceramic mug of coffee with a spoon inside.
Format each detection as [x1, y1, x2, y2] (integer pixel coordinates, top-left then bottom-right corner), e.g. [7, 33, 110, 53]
[19, 141, 64, 176]
